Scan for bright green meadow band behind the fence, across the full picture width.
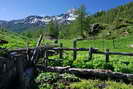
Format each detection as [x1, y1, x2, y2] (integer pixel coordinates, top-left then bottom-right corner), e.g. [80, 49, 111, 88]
[0, 30, 133, 52]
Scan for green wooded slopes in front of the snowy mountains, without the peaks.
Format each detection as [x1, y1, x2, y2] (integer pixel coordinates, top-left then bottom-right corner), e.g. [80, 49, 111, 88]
[20, 2, 133, 39]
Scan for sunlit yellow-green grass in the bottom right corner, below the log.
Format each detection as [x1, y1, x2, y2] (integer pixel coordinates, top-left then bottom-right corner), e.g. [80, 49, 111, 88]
[70, 80, 133, 89]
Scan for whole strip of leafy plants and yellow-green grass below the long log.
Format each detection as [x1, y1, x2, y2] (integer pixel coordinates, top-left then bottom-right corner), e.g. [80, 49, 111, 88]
[35, 72, 133, 89]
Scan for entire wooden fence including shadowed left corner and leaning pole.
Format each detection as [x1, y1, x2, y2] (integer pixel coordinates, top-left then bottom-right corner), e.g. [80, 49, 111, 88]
[0, 36, 133, 89]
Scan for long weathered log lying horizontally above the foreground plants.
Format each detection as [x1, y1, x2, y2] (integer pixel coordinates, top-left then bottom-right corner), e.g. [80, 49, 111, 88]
[36, 66, 133, 83]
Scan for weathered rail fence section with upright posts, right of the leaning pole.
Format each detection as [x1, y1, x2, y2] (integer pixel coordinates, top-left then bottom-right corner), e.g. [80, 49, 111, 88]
[39, 39, 133, 66]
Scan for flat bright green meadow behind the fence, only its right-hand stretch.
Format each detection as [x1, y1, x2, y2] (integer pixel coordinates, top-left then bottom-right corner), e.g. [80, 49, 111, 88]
[60, 36, 133, 52]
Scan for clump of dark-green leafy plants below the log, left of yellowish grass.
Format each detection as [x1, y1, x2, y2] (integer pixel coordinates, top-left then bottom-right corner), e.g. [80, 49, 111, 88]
[35, 72, 80, 89]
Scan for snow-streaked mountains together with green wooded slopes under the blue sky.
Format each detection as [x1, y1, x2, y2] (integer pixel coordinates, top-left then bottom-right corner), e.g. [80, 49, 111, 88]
[0, 2, 133, 39]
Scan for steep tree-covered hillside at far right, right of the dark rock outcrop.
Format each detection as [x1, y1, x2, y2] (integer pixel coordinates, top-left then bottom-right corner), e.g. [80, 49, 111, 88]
[92, 2, 133, 39]
